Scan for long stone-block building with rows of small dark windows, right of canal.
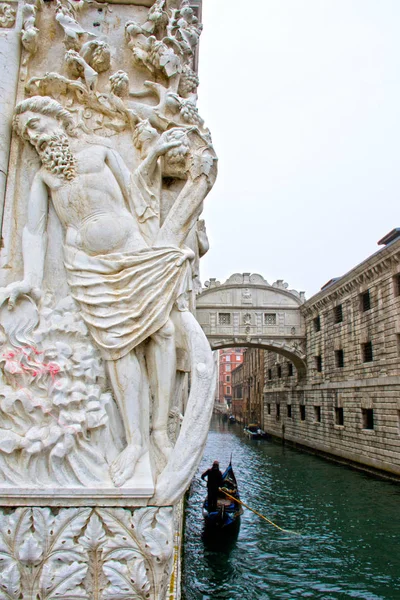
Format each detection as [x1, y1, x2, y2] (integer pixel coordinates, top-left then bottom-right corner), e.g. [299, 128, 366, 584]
[263, 230, 400, 477]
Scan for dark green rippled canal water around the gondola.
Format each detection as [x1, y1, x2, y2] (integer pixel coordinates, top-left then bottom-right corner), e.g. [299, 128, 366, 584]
[183, 419, 400, 600]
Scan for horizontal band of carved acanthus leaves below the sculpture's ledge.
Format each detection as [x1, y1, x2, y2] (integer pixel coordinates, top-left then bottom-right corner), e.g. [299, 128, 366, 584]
[0, 508, 173, 600]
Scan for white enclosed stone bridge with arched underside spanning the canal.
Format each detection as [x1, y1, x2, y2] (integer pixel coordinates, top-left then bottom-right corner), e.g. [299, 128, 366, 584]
[196, 273, 306, 376]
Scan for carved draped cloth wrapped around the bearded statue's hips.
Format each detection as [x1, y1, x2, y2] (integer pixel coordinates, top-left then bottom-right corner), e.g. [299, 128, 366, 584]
[64, 246, 188, 360]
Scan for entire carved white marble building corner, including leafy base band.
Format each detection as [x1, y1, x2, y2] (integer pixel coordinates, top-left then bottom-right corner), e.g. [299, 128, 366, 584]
[0, 0, 217, 599]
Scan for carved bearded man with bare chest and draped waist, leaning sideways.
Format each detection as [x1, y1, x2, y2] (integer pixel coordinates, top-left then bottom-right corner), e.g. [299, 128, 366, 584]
[0, 96, 216, 486]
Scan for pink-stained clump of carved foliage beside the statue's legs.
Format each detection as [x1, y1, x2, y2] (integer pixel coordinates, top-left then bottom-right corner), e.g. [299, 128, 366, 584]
[0, 296, 122, 487]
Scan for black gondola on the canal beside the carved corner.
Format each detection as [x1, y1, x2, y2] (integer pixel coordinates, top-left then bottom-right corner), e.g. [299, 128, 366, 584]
[203, 462, 243, 531]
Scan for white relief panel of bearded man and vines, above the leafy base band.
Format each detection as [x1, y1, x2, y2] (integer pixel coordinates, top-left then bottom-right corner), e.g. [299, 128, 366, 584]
[0, 0, 217, 520]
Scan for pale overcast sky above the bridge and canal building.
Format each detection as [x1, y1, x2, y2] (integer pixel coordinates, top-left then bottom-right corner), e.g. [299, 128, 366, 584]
[199, 0, 400, 297]
